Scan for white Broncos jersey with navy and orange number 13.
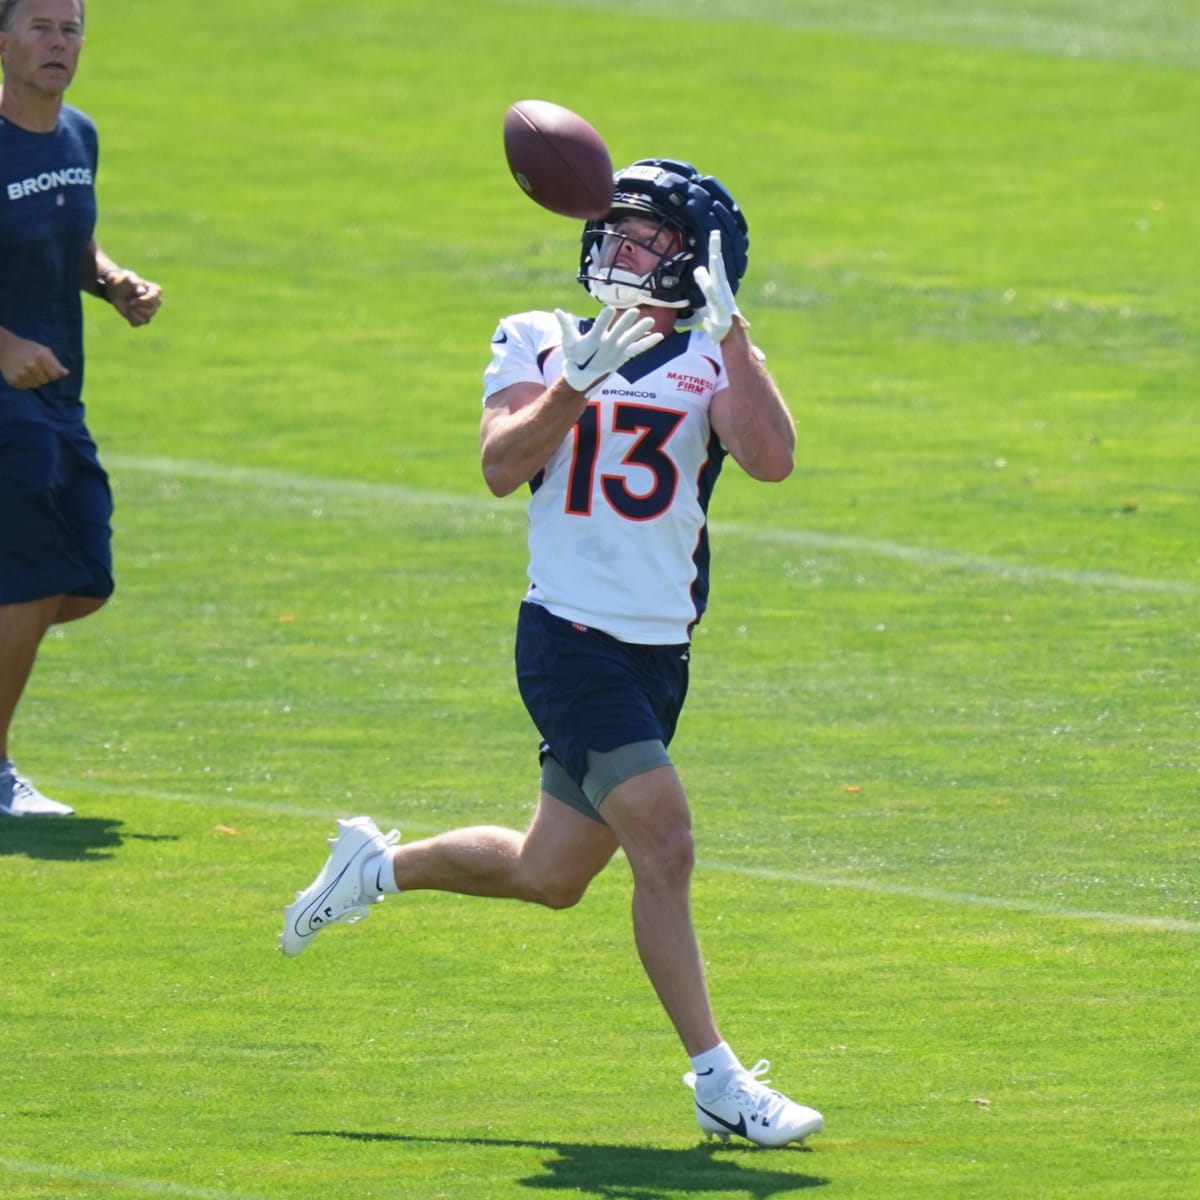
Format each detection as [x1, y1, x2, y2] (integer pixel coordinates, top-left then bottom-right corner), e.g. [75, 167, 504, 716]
[484, 312, 726, 646]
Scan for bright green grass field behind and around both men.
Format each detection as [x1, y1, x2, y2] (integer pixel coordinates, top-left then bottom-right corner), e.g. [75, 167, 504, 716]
[0, 0, 1200, 1200]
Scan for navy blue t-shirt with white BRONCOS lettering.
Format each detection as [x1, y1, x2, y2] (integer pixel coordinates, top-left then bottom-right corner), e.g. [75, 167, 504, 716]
[0, 104, 97, 421]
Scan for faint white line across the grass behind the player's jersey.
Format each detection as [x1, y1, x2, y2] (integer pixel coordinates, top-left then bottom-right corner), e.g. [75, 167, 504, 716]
[107, 455, 1200, 595]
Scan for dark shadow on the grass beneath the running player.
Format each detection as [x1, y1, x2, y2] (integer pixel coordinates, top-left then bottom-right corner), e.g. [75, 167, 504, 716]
[296, 1129, 829, 1200]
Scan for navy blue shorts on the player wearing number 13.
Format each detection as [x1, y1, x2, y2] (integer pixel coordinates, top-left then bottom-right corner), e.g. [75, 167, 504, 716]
[516, 602, 690, 787]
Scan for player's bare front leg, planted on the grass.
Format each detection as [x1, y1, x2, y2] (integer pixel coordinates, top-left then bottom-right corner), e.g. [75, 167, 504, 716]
[601, 767, 721, 1056]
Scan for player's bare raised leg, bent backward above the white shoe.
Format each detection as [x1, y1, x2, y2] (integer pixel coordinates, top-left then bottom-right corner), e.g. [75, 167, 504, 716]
[390, 792, 617, 908]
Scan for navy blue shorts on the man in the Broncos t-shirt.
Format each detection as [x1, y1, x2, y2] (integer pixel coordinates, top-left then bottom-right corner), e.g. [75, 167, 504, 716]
[0, 415, 113, 605]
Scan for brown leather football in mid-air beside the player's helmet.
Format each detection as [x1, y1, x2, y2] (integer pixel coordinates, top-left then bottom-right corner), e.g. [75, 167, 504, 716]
[504, 100, 612, 221]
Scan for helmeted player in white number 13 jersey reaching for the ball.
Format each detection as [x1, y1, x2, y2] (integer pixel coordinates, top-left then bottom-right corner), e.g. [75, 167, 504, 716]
[282, 158, 823, 1146]
